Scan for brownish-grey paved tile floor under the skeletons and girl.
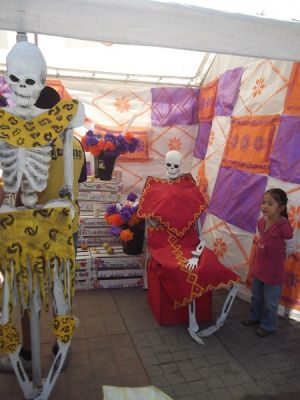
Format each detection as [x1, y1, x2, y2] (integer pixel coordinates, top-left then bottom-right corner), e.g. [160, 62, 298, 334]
[0, 289, 300, 400]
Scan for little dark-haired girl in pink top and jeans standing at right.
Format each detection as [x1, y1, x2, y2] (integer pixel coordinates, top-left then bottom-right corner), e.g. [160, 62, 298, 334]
[243, 188, 293, 337]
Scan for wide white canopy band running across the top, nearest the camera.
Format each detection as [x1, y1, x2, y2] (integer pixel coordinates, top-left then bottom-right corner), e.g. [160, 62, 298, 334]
[0, 0, 300, 61]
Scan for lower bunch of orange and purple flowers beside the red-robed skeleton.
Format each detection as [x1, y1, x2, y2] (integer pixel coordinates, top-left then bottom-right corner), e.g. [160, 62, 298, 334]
[104, 193, 144, 242]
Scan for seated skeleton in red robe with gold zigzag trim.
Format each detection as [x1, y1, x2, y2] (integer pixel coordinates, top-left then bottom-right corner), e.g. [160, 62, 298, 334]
[140, 150, 239, 344]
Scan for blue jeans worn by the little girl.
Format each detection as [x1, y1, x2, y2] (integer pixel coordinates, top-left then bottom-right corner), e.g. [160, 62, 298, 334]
[250, 277, 282, 331]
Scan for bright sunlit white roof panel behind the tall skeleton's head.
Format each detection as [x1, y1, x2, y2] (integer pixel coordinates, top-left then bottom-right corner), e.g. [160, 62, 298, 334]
[0, 31, 213, 85]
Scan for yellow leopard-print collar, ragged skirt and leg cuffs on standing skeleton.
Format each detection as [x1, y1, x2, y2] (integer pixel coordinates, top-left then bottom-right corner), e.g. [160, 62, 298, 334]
[0, 100, 78, 352]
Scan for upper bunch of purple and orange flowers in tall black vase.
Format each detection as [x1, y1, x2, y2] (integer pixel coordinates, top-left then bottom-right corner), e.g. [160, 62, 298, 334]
[81, 130, 140, 157]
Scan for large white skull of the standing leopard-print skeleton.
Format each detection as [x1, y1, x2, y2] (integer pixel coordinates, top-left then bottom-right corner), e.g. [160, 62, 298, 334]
[6, 42, 47, 108]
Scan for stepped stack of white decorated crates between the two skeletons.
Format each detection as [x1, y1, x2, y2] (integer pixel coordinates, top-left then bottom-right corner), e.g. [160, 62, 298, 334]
[75, 180, 144, 290]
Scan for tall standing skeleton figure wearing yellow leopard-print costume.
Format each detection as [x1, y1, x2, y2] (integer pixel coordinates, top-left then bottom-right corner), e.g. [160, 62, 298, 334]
[0, 42, 84, 399]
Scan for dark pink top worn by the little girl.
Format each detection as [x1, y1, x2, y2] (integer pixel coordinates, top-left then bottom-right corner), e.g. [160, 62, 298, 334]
[253, 217, 293, 285]
